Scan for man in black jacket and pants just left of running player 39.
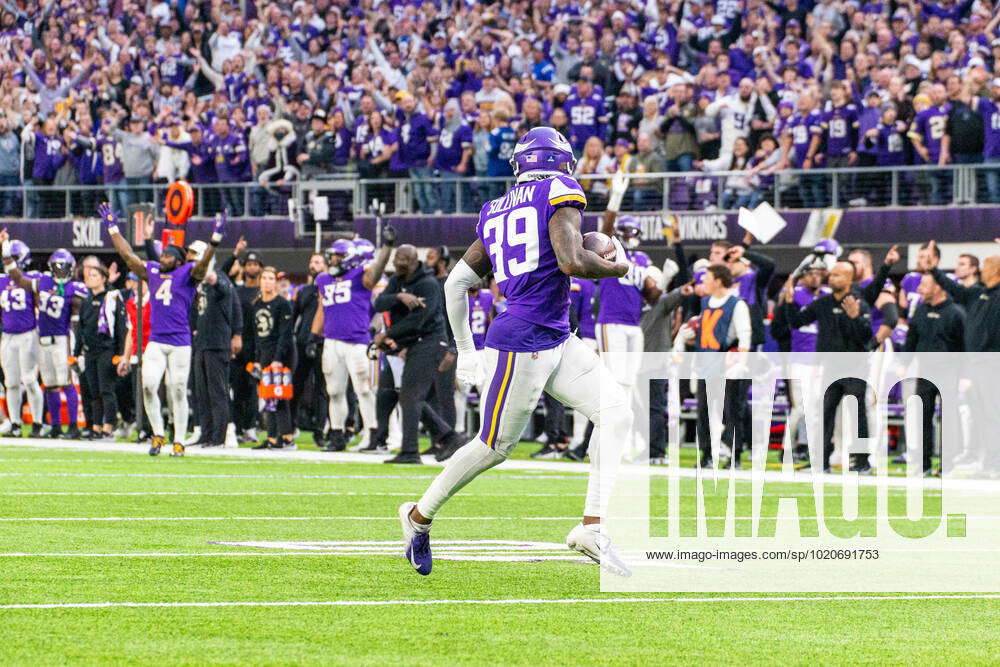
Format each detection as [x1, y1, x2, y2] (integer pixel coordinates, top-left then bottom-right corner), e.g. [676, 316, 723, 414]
[375, 244, 458, 463]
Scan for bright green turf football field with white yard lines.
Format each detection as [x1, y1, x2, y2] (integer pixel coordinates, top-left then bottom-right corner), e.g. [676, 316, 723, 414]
[0, 444, 1000, 665]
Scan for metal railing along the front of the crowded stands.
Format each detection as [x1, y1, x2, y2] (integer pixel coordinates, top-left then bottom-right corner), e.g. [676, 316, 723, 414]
[0, 163, 1000, 222]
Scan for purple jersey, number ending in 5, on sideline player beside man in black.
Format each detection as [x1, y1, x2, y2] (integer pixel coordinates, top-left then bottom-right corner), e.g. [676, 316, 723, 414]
[316, 266, 372, 345]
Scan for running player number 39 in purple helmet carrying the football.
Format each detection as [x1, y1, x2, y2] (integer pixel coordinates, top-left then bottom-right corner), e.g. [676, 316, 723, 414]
[399, 127, 632, 576]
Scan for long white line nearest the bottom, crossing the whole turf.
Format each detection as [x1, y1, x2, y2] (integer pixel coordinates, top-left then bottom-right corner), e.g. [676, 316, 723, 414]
[0, 594, 1000, 609]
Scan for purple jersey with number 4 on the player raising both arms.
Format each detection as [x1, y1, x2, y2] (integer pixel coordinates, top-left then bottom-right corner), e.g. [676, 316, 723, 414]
[146, 262, 198, 346]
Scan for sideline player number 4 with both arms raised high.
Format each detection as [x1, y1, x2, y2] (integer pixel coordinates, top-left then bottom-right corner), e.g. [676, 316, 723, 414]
[97, 203, 226, 456]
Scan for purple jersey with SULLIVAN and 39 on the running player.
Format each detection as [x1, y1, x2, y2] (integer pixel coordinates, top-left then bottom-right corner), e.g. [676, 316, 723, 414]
[476, 176, 587, 352]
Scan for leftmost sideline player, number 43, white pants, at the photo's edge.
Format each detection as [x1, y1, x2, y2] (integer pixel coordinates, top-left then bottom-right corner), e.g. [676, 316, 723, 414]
[0, 236, 42, 438]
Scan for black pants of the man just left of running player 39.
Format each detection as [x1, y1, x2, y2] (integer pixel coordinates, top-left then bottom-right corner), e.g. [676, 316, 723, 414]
[399, 339, 453, 454]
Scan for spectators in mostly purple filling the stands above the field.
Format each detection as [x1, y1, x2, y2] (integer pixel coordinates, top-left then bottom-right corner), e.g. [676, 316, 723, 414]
[0, 0, 1000, 218]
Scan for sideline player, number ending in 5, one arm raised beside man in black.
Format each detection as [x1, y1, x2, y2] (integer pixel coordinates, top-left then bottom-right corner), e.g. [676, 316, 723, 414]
[306, 232, 396, 451]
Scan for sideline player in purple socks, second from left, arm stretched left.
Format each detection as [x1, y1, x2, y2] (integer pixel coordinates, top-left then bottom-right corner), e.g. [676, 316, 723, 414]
[0, 235, 89, 439]
